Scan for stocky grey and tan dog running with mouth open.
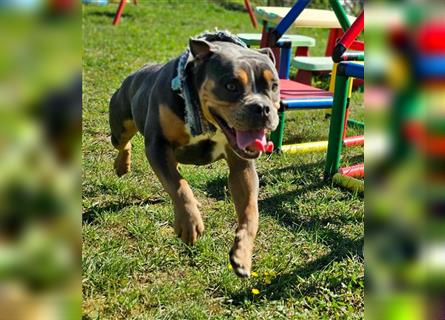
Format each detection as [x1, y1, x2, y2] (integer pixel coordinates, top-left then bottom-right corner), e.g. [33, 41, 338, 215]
[109, 31, 280, 277]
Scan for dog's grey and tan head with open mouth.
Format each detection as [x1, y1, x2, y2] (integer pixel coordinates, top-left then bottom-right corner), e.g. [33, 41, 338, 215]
[190, 39, 279, 159]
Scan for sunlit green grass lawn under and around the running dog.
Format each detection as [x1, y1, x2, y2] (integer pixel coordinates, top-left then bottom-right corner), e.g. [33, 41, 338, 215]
[82, 1, 364, 319]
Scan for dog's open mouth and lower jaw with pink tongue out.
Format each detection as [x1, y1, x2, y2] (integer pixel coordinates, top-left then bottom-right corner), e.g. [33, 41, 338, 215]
[212, 112, 273, 159]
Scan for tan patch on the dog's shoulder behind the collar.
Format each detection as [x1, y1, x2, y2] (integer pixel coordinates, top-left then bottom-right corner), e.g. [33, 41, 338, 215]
[159, 105, 190, 146]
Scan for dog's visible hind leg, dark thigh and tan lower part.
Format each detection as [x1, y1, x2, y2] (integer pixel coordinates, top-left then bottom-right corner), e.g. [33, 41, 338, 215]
[110, 91, 137, 177]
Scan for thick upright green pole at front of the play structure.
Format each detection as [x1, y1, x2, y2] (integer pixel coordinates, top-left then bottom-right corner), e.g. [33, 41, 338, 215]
[325, 73, 350, 178]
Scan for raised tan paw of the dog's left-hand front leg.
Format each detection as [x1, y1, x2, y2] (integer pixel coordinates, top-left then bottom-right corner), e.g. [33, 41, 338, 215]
[175, 205, 204, 245]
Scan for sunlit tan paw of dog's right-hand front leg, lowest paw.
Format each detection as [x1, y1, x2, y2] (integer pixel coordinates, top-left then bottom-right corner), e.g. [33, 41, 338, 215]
[229, 232, 253, 278]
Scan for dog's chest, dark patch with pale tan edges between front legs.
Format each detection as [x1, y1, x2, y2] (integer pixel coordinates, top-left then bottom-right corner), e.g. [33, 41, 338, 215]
[175, 130, 227, 165]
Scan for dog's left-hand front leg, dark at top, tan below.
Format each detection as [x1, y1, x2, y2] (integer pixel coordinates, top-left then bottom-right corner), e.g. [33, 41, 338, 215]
[145, 139, 204, 244]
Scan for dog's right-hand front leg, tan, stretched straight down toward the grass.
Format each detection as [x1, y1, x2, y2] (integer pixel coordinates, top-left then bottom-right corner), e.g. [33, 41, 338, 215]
[227, 150, 259, 277]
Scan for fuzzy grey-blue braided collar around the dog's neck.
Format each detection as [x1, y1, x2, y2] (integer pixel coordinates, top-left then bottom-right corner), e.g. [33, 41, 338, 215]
[171, 31, 247, 136]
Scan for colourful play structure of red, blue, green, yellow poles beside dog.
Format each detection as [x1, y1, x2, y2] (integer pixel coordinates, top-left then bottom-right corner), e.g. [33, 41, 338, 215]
[262, 0, 364, 192]
